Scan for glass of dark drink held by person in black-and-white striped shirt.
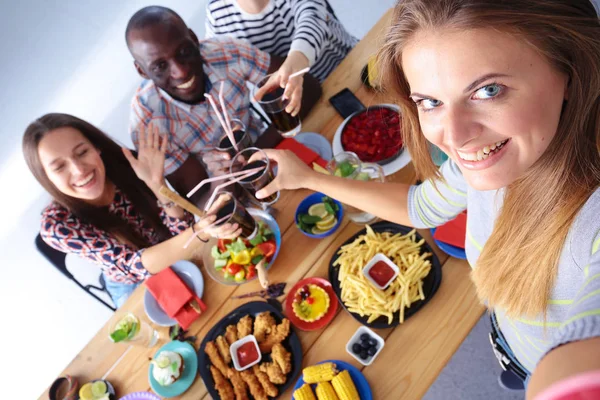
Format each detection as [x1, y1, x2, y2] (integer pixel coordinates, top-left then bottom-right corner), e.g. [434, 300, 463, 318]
[253, 74, 302, 137]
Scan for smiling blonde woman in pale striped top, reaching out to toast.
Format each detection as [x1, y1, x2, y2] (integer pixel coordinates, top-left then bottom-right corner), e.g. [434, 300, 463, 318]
[256, 0, 600, 398]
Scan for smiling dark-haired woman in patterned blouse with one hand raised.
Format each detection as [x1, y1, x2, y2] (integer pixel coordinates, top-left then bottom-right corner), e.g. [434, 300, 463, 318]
[23, 114, 240, 306]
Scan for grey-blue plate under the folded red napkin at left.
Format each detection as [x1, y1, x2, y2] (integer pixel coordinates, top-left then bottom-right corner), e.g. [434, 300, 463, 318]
[144, 260, 204, 326]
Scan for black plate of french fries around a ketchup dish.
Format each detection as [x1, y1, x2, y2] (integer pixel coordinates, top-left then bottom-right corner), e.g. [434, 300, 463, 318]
[329, 221, 442, 328]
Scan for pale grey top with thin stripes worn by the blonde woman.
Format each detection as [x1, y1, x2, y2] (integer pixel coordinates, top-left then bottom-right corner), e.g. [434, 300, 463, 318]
[408, 160, 600, 372]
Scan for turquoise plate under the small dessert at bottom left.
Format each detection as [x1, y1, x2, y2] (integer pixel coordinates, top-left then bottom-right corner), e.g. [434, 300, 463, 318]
[148, 340, 198, 397]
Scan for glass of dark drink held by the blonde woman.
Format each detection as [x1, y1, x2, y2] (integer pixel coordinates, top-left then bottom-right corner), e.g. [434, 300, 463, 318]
[229, 147, 280, 208]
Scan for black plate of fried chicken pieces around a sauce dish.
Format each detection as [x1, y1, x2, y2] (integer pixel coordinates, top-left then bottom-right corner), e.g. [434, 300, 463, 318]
[198, 301, 302, 400]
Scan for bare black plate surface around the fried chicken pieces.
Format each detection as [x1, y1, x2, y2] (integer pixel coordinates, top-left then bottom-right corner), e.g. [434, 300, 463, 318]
[198, 301, 302, 399]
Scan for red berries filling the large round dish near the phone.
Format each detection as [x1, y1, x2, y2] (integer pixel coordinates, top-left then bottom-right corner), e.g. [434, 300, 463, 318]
[341, 106, 402, 165]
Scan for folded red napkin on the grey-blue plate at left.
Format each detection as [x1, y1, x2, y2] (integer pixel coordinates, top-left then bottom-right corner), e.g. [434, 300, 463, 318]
[146, 267, 206, 330]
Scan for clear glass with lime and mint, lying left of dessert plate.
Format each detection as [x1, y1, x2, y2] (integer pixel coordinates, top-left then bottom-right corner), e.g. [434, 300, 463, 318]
[109, 313, 159, 347]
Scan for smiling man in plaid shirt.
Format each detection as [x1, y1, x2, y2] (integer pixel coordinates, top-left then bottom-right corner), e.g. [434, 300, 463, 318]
[126, 6, 320, 203]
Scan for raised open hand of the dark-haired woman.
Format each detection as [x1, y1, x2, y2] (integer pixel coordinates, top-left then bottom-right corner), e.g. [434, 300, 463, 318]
[122, 123, 168, 193]
